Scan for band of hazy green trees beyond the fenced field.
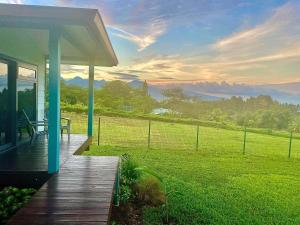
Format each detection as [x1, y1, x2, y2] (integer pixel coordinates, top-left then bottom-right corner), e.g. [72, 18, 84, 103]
[61, 80, 300, 132]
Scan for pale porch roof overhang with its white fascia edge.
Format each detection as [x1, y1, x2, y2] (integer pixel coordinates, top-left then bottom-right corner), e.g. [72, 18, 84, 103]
[0, 4, 118, 66]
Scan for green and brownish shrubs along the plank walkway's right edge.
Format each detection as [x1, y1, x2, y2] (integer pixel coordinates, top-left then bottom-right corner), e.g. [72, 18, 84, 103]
[111, 154, 166, 225]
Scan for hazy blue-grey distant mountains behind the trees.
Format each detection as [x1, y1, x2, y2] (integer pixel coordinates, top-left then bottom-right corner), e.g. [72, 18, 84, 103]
[65, 77, 300, 104]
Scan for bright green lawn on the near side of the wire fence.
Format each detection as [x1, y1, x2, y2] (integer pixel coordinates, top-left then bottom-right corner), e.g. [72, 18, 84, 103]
[85, 146, 300, 225]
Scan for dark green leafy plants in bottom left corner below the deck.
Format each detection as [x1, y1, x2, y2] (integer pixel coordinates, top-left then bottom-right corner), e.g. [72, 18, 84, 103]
[0, 187, 36, 224]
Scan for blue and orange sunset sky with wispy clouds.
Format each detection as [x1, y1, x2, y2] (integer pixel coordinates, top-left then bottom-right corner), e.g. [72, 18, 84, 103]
[0, 0, 300, 84]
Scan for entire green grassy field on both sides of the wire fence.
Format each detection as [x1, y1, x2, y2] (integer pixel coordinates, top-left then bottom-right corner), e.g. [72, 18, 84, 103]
[67, 115, 300, 225]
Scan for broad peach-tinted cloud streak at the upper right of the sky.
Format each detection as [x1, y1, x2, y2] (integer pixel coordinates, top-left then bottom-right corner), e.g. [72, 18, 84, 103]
[212, 1, 300, 64]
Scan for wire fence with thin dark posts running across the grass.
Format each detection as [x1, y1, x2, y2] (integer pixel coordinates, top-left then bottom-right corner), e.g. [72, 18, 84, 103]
[65, 113, 300, 159]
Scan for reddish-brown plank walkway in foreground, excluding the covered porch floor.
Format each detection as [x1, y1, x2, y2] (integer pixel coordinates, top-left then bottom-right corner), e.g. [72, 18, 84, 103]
[8, 156, 119, 225]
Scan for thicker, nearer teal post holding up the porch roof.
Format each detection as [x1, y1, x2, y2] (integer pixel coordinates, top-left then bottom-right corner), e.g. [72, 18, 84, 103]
[48, 29, 61, 174]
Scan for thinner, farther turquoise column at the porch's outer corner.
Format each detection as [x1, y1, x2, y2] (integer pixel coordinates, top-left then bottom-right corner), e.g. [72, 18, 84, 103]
[88, 65, 95, 137]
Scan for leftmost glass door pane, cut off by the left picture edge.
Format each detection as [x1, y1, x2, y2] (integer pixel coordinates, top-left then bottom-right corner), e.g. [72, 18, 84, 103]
[0, 61, 12, 152]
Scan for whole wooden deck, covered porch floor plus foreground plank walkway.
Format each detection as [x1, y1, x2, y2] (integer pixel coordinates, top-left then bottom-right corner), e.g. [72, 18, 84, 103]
[0, 135, 119, 225]
